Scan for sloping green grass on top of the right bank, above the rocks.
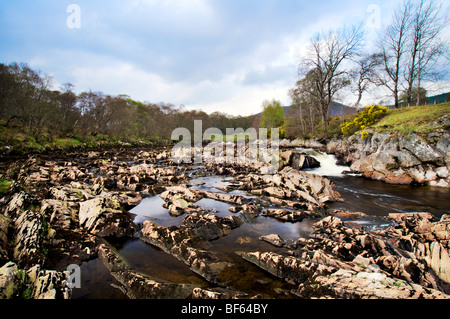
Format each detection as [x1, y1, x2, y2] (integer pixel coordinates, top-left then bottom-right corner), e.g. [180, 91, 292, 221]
[371, 102, 450, 135]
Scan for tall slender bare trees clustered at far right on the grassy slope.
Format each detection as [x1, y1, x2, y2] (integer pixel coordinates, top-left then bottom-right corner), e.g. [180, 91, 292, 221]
[377, 0, 448, 108]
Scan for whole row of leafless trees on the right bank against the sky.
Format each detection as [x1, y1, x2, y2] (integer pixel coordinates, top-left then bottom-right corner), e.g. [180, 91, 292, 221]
[287, 0, 450, 136]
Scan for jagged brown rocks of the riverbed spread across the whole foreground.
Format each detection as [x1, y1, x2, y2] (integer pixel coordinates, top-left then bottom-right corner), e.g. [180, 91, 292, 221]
[0, 149, 450, 299]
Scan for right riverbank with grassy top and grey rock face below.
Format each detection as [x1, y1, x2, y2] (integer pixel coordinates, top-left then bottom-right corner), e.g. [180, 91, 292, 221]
[327, 103, 450, 188]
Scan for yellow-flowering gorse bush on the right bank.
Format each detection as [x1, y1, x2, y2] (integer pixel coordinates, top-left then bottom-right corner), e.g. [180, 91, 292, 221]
[341, 105, 387, 136]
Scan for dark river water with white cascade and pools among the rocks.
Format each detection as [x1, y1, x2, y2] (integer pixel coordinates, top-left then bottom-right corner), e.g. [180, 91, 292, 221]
[73, 149, 450, 299]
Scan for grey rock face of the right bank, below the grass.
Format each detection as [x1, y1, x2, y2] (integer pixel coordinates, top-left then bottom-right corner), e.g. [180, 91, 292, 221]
[327, 131, 450, 187]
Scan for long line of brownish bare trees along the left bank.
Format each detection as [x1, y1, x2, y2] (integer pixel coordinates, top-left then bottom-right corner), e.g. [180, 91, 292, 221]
[0, 63, 252, 145]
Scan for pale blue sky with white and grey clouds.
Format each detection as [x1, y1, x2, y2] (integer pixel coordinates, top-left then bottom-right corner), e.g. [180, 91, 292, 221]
[0, 0, 442, 115]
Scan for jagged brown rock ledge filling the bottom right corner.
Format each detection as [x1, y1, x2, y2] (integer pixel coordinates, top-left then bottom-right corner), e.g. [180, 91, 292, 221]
[237, 214, 450, 299]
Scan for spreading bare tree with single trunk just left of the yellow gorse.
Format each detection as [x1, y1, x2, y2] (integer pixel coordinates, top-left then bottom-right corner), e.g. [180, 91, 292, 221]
[299, 24, 364, 130]
